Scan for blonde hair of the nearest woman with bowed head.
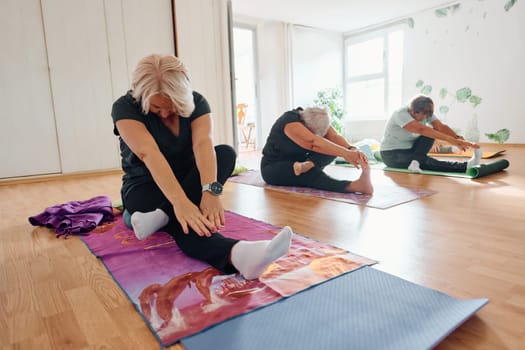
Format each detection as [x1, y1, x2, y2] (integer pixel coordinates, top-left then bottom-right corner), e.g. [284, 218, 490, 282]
[131, 54, 195, 117]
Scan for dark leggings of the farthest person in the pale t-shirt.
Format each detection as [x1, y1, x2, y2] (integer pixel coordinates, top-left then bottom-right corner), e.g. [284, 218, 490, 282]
[381, 136, 467, 173]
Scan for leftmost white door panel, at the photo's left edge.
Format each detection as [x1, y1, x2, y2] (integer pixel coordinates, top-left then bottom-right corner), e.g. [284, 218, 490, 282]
[0, 0, 61, 178]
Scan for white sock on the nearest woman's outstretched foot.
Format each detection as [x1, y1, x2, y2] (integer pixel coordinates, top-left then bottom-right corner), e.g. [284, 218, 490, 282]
[231, 226, 293, 280]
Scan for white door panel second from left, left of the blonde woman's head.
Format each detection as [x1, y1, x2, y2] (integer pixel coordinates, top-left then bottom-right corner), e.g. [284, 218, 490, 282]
[42, 0, 119, 173]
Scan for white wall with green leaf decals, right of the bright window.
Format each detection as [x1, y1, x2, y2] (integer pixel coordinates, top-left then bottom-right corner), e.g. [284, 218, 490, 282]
[404, 0, 525, 143]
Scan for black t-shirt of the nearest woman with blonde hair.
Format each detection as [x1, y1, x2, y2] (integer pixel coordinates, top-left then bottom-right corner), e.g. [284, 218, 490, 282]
[111, 91, 210, 191]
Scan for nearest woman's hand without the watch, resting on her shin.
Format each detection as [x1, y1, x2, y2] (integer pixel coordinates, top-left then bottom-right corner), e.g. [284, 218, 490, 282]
[173, 198, 217, 237]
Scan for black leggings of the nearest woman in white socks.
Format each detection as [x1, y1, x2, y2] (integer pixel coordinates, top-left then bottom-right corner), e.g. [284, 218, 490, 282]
[122, 145, 238, 273]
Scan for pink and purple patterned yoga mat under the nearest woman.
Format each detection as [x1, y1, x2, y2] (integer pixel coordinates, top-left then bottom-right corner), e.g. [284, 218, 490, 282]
[82, 212, 375, 346]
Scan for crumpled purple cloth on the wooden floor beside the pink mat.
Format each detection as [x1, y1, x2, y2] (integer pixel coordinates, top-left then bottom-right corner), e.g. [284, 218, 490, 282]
[29, 196, 113, 237]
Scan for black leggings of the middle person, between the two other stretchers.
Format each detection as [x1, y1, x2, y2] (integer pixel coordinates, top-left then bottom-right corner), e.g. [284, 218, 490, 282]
[261, 152, 351, 193]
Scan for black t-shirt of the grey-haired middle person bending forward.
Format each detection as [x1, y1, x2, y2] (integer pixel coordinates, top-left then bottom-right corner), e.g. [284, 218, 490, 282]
[263, 110, 309, 162]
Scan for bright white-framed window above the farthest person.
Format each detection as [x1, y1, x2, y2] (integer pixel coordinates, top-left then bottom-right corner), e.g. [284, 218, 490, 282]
[345, 27, 403, 120]
